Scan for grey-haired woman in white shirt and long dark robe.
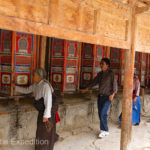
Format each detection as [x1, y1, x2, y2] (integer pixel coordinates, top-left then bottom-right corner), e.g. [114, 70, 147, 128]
[16, 68, 58, 150]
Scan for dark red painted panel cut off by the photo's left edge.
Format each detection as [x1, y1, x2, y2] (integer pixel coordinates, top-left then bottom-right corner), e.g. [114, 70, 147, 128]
[0, 30, 12, 93]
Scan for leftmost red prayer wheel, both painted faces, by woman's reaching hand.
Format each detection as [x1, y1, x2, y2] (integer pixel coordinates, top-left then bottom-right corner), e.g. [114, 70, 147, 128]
[0, 30, 34, 94]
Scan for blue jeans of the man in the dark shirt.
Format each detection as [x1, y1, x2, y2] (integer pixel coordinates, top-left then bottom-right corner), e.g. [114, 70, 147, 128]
[97, 95, 111, 131]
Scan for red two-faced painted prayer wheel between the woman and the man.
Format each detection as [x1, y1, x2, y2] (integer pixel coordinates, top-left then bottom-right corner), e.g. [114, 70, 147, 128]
[51, 38, 79, 92]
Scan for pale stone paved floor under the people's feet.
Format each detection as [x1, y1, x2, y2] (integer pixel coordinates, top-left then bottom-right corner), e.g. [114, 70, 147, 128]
[0, 117, 150, 150]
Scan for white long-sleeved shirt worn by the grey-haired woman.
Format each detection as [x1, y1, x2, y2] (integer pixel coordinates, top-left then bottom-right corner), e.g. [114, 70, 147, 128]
[16, 80, 53, 118]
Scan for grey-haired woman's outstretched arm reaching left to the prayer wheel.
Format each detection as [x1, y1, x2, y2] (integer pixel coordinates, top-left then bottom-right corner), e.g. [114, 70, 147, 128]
[15, 85, 34, 94]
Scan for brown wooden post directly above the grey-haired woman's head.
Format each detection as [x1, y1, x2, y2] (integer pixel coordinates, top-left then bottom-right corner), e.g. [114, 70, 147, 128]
[40, 36, 46, 69]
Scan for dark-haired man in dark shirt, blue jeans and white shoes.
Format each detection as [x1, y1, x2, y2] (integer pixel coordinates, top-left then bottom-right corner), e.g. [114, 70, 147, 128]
[82, 58, 117, 138]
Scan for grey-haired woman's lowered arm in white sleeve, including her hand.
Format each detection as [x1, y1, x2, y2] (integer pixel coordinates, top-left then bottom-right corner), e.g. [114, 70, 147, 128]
[43, 84, 52, 122]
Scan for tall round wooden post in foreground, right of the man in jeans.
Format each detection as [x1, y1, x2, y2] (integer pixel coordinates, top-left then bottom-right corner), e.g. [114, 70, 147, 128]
[120, 6, 136, 150]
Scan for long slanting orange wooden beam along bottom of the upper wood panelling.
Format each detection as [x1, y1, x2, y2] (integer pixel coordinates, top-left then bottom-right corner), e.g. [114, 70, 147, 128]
[0, 15, 130, 49]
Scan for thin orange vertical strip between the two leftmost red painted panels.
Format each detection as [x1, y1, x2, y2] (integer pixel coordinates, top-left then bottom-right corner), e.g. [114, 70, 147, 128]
[10, 31, 16, 96]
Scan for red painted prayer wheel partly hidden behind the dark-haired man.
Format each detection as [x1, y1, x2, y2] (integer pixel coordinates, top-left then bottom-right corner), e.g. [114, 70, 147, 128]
[81, 43, 106, 87]
